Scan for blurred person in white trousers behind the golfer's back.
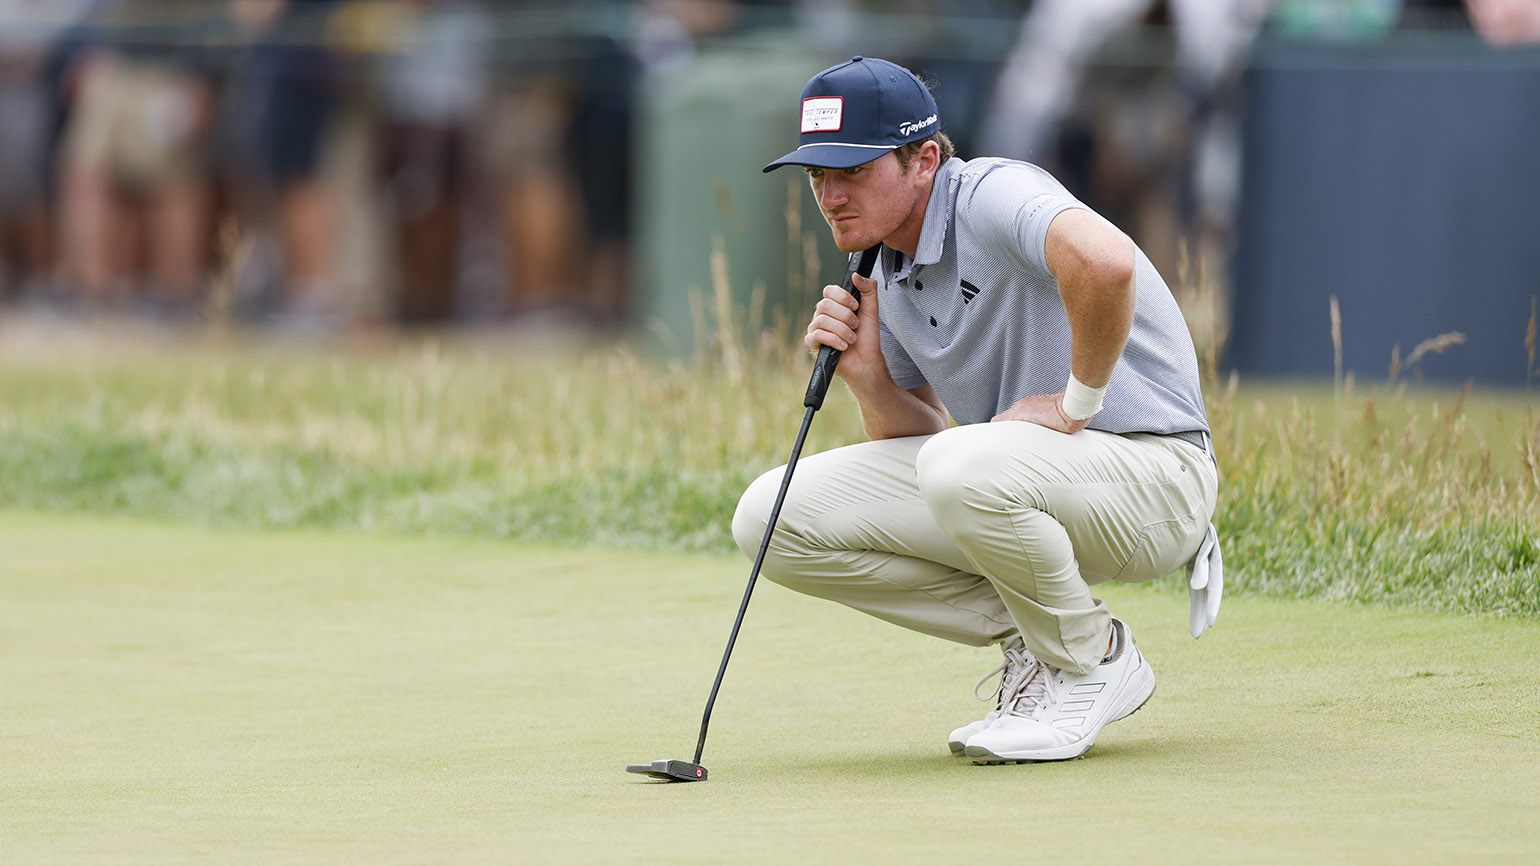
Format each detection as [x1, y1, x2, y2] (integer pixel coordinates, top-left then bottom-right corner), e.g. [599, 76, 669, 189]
[981, 0, 1271, 282]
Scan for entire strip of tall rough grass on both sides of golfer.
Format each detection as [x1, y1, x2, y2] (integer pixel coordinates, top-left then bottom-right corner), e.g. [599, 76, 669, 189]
[0, 318, 1540, 616]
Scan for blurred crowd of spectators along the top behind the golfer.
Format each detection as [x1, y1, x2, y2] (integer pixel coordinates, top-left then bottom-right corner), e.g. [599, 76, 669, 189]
[0, 0, 1540, 375]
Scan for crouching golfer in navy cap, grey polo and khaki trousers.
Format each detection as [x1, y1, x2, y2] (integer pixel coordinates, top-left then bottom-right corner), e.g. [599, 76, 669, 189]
[733, 57, 1221, 763]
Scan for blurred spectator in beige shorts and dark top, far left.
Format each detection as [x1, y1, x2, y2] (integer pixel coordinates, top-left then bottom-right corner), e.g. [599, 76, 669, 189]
[60, 0, 214, 317]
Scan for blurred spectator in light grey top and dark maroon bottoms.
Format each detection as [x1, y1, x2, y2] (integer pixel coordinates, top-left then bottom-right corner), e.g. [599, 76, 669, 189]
[380, 0, 488, 324]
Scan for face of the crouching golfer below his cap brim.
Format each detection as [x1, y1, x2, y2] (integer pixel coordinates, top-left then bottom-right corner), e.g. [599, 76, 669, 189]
[805, 151, 926, 253]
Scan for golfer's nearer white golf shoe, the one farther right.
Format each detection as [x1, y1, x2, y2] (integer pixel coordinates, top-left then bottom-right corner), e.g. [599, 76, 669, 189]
[964, 619, 1155, 764]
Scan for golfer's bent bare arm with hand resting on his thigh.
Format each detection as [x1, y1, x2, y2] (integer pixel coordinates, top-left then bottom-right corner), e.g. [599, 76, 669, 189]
[993, 208, 1135, 433]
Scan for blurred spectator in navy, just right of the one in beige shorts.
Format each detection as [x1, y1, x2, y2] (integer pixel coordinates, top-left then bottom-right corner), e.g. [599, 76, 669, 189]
[223, 0, 343, 330]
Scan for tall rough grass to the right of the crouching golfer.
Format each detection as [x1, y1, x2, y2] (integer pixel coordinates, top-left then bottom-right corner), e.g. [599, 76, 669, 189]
[1210, 377, 1540, 615]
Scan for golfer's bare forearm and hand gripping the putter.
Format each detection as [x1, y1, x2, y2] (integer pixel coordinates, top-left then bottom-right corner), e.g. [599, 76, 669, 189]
[802, 274, 949, 439]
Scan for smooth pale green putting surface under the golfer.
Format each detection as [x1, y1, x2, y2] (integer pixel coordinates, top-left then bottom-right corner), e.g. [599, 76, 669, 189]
[0, 512, 1540, 864]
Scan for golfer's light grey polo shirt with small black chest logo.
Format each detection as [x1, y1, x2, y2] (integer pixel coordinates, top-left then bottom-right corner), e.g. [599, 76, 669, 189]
[876, 159, 1209, 433]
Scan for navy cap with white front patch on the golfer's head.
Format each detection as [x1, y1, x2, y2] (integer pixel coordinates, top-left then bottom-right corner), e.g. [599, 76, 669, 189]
[764, 55, 941, 171]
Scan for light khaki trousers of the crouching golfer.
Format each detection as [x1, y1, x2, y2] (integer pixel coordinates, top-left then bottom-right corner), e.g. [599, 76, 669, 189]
[733, 421, 1218, 673]
